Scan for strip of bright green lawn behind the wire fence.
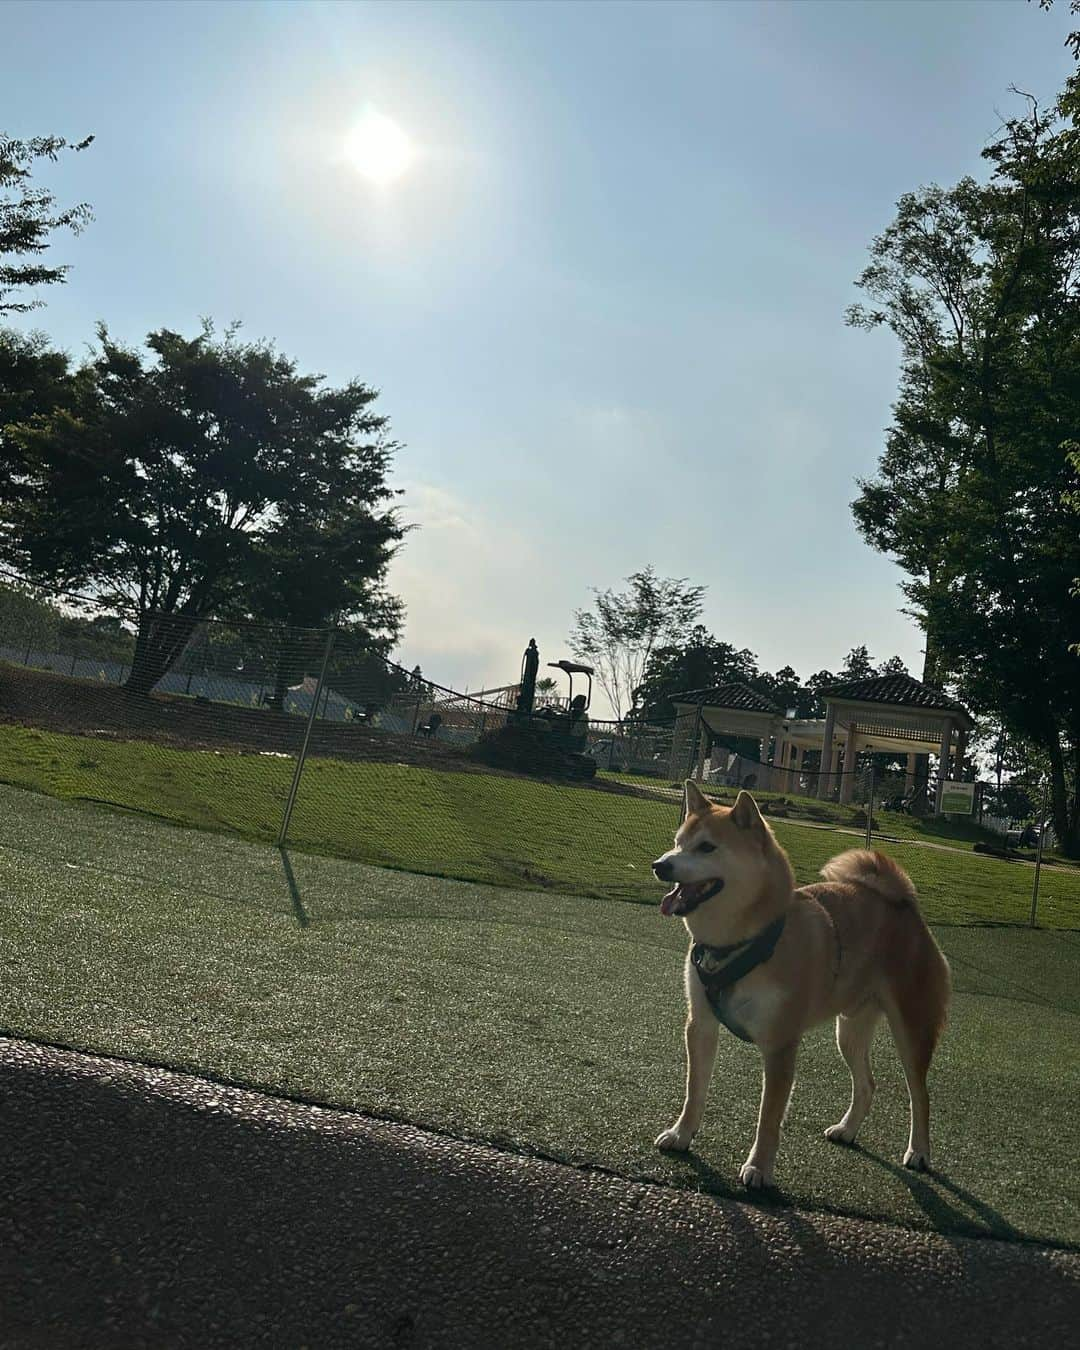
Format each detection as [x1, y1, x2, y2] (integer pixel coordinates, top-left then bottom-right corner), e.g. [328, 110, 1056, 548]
[0, 726, 1080, 927]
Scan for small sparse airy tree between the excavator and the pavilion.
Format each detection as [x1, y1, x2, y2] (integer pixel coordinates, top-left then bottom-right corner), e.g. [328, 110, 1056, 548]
[568, 567, 705, 720]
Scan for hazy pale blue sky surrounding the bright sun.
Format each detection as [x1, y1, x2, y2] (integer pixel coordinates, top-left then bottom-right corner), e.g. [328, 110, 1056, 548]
[0, 0, 1072, 712]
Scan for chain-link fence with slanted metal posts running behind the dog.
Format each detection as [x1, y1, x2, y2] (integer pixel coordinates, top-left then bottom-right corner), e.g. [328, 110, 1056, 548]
[0, 585, 1080, 926]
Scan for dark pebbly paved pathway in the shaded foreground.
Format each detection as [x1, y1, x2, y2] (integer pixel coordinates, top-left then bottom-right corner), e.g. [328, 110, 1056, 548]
[0, 1040, 1080, 1350]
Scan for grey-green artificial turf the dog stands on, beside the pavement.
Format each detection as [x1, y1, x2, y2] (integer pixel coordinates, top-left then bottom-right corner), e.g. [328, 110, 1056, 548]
[0, 788, 1080, 1246]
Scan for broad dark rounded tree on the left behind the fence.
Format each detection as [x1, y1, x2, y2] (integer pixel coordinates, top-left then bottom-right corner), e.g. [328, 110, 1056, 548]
[0, 324, 402, 691]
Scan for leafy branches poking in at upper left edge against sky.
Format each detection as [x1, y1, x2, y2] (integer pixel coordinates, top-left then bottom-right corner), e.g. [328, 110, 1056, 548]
[0, 132, 93, 315]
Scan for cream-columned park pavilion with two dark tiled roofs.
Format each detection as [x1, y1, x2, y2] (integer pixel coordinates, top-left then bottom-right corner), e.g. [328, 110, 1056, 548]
[671, 675, 975, 813]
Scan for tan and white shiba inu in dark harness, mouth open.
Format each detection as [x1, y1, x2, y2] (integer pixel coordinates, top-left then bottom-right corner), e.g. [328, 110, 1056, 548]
[652, 780, 950, 1187]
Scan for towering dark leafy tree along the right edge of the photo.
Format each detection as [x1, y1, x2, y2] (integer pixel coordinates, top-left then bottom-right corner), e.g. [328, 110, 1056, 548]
[851, 78, 1080, 853]
